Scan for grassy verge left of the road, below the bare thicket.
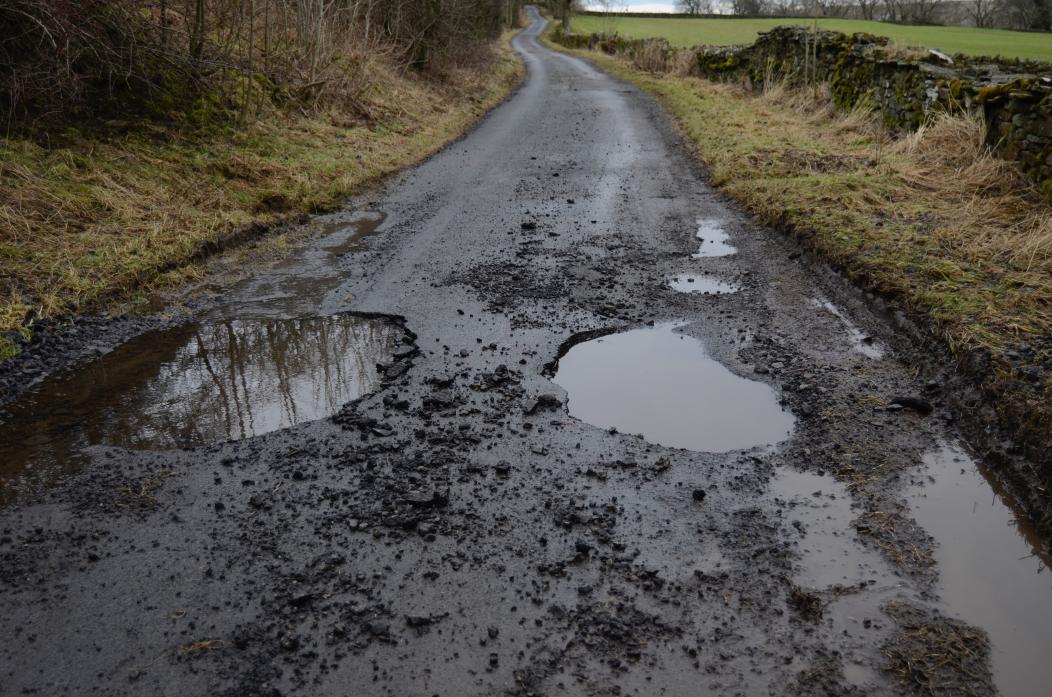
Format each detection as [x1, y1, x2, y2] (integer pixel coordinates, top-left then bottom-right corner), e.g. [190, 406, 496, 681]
[0, 32, 523, 358]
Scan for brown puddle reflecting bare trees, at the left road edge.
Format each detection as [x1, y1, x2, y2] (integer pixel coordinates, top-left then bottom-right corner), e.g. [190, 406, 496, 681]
[0, 314, 405, 494]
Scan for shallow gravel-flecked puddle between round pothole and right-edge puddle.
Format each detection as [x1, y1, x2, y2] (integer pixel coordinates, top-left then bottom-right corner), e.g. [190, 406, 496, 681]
[770, 469, 888, 590]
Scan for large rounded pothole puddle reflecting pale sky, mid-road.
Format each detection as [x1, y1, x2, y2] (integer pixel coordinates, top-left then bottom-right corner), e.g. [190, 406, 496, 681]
[552, 324, 794, 452]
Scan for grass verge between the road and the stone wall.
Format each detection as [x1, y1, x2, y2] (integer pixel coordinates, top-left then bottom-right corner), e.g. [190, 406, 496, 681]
[552, 25, 1052, 531]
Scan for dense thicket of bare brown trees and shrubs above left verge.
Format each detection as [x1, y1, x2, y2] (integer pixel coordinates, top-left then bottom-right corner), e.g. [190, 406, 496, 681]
[0, 0, 521, 128]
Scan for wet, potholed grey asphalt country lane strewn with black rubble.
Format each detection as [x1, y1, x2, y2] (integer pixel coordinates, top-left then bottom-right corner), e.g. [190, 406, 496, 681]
[0, 9, 1052, 696]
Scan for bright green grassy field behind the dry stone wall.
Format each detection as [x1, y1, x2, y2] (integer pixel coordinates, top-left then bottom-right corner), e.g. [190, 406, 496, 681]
[573, 15, 1052, 62]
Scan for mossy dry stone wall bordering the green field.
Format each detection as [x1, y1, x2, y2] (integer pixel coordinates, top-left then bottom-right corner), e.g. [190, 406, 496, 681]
[554, 26, 1052, 199]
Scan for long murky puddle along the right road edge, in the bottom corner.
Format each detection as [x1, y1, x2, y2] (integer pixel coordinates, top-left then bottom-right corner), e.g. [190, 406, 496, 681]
[908, 444, 1052, 697]
